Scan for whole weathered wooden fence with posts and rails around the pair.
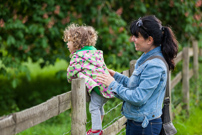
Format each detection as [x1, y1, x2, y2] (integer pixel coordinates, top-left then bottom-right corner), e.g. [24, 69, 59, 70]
[0, 41, 199, 135]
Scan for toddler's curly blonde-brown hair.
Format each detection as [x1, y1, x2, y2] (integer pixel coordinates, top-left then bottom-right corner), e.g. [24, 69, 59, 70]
[63, 23, 98, 50]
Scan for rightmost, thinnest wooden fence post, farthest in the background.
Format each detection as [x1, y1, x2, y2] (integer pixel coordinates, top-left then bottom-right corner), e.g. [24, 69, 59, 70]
[193, 40, 199, 103]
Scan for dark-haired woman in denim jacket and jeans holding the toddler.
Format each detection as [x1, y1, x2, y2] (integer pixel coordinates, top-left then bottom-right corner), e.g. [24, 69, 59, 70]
[97, 16, 178, 135]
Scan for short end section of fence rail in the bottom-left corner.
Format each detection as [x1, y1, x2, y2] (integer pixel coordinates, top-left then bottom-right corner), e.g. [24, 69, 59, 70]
[0, 115, 15, 135]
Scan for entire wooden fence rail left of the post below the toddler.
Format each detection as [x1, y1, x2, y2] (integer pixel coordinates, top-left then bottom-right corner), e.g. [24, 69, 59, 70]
[0, 91, 71, 135]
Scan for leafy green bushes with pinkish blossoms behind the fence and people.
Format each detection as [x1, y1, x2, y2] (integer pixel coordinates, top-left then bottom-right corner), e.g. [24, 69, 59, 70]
[0, 0, 202, 122]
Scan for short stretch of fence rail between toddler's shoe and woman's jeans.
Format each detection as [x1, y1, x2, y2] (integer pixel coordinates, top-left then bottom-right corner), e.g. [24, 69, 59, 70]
[103, 116, 126, 135]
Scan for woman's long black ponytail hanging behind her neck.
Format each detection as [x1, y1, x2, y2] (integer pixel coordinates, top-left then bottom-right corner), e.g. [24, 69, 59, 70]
[161, 26, 178, 70]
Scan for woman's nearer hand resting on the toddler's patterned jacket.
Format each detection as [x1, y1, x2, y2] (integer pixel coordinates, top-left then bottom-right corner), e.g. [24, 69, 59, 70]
[96, 74, 114, 87]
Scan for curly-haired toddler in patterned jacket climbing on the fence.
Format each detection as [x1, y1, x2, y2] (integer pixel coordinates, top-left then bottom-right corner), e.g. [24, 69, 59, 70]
[64, 24, 114, 135]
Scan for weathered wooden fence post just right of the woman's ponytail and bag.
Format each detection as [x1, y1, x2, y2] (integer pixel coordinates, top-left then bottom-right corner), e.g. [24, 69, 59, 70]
[182, 47, 189, 116]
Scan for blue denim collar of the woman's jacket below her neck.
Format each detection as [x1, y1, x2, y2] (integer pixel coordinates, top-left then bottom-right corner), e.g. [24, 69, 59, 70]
[137, 46, 161, 66]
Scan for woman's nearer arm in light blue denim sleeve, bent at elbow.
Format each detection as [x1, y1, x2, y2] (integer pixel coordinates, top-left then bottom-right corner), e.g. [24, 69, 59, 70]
[99, 64, 165, 106]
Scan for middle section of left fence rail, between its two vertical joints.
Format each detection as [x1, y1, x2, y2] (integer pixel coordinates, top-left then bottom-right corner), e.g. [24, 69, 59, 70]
[15, 97, 59, 134]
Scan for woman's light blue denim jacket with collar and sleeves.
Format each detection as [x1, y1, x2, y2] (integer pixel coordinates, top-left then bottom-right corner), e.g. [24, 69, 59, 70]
[108, 46, 167, 128]
